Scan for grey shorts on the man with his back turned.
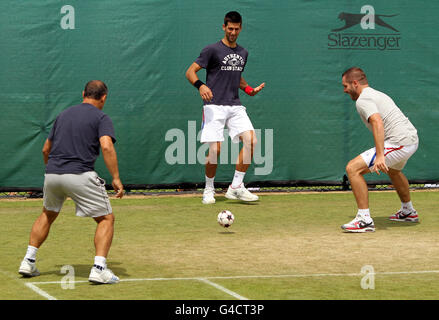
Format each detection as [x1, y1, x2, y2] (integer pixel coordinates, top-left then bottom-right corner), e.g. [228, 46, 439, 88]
[43, 171, 113, 218]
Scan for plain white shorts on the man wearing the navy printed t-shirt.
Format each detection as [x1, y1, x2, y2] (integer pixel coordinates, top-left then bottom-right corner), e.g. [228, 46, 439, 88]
[200, 104, 254, 143]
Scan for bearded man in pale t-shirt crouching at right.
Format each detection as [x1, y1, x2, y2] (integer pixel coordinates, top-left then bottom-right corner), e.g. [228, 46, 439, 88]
[342, 67, 419, 232]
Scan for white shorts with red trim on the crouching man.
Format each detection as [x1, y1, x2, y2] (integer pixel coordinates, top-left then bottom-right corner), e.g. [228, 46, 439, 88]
[361, 142, 418, 171]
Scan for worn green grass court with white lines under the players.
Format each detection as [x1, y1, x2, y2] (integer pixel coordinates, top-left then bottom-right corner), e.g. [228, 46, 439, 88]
[0, 191, 439, 300]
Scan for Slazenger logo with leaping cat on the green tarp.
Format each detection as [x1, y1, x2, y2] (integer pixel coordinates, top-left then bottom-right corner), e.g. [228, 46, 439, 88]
[328, 5, 401, 50]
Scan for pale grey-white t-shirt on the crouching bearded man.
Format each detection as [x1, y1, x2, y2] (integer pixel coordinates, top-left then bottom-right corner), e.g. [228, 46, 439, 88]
[356, 87, 419, 146]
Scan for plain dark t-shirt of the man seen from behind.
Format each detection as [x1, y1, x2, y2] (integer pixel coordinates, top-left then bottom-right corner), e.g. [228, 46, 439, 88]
[46, 103, 116, 174]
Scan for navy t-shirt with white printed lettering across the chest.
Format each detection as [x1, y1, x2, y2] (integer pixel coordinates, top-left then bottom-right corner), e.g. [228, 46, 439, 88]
[195, 40, 248, 106]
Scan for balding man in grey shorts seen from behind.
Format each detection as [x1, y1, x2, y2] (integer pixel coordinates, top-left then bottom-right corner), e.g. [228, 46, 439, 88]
[18, 80, 123, 283]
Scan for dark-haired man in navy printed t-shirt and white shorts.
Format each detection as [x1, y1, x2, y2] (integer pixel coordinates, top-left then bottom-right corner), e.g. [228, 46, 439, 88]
[186, 11, 265, 204]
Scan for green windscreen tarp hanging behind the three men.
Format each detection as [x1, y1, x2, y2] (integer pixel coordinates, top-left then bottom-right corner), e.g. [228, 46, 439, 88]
[0, 0, 439, 187]
